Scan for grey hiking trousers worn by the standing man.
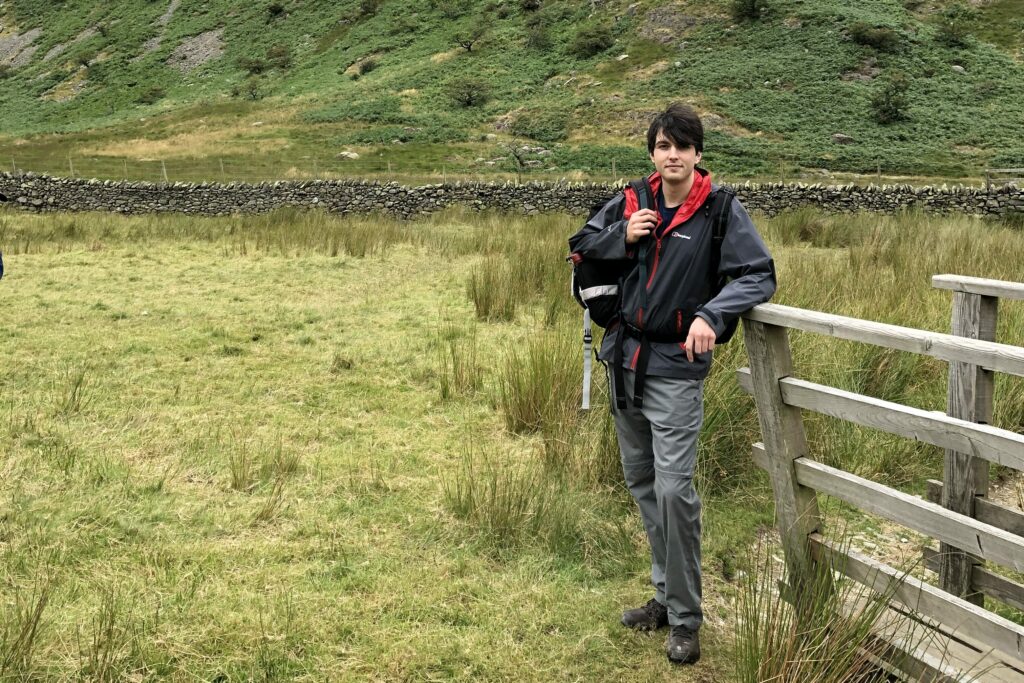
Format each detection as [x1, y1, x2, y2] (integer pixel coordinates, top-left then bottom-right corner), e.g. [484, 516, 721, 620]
[608, 370, 703, 630]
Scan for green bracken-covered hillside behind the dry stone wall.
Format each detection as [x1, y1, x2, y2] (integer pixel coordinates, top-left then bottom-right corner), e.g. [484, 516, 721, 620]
[0, 0, 1024, 178]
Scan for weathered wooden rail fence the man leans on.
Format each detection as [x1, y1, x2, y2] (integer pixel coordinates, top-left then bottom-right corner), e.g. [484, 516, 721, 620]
[737, 275, 1024, 682]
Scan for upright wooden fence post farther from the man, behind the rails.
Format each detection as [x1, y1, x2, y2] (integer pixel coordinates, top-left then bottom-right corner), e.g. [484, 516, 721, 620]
[939, 292, 998, 605]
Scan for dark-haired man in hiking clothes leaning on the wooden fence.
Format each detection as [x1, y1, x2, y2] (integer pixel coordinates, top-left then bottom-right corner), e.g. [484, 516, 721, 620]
[569, 103, 775, 664]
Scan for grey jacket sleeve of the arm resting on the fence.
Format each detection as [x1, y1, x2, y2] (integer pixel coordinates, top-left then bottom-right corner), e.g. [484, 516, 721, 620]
[696, 199, 777, 336]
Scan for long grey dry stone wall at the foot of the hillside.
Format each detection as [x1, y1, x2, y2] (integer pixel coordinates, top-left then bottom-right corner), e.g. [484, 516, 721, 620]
[0, 173, 1024, 218]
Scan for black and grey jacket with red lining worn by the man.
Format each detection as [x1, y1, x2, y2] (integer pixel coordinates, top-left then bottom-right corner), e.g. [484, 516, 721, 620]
[569, 169, 776, 379]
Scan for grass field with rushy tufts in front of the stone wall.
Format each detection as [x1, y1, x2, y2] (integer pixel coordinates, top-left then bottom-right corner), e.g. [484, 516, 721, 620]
[0, 205, 1024, 682]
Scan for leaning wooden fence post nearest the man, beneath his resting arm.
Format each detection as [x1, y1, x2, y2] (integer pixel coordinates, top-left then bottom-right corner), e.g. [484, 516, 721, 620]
[743, 318, 821, 586]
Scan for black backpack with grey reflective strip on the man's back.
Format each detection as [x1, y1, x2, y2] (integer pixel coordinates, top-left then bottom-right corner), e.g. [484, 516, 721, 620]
[566, 178, 739, 411]
